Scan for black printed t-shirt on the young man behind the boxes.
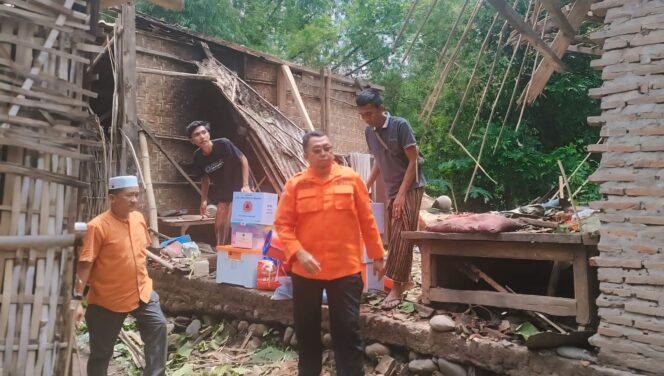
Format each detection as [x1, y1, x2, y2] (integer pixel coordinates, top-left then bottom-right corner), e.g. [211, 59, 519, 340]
[194, 138, 243, 205]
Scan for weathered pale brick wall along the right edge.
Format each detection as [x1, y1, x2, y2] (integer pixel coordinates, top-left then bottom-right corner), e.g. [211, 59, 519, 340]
[588, 0, 664, 375]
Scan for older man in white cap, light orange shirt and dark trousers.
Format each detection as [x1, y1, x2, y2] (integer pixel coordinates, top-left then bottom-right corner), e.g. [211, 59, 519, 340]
[74, 176, 167, 376]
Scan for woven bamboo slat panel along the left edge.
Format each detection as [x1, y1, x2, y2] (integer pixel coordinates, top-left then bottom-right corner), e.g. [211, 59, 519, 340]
[0, 0, 97, 375]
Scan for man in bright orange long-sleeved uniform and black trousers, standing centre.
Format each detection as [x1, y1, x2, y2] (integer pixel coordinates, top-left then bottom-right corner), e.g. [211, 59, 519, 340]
[275, 131, 383, 376]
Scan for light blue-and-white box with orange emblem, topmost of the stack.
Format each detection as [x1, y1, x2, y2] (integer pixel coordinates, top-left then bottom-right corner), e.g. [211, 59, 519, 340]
[231, 192, 277, 226]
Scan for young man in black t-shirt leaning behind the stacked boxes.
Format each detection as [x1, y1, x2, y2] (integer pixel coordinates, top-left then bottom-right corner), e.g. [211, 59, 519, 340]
[187, 120, 251, 245]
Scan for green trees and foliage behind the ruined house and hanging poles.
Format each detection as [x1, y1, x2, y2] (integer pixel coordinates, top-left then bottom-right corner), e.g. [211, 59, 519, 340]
[137, 0, 601, 210]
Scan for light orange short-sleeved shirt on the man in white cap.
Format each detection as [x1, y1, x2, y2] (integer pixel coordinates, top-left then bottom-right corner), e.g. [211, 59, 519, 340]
[79, 210, 152, 312]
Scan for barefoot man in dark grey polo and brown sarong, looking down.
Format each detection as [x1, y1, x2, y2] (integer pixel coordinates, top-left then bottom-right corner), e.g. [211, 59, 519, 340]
[355, 89, 425, 309]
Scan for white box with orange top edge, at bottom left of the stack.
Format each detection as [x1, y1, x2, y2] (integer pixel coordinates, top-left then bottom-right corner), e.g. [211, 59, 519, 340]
[217, 245, 263, 289]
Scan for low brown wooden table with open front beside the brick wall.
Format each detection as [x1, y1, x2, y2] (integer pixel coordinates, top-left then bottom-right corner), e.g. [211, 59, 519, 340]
[403, 231, 597, 325]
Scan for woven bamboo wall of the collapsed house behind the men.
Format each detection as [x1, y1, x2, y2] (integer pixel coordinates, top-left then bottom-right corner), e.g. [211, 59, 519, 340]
[131, 18, 367, 213]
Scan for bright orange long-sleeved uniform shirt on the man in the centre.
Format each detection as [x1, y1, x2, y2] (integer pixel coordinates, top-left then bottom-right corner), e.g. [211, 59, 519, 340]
[274, 163, 383, 280]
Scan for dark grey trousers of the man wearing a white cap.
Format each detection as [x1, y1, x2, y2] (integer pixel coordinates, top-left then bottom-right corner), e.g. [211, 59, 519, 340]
[85, 291, 168, 376]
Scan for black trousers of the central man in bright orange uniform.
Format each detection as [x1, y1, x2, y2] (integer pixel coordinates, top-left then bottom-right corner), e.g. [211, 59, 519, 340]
[292, 273, 364, 376]
